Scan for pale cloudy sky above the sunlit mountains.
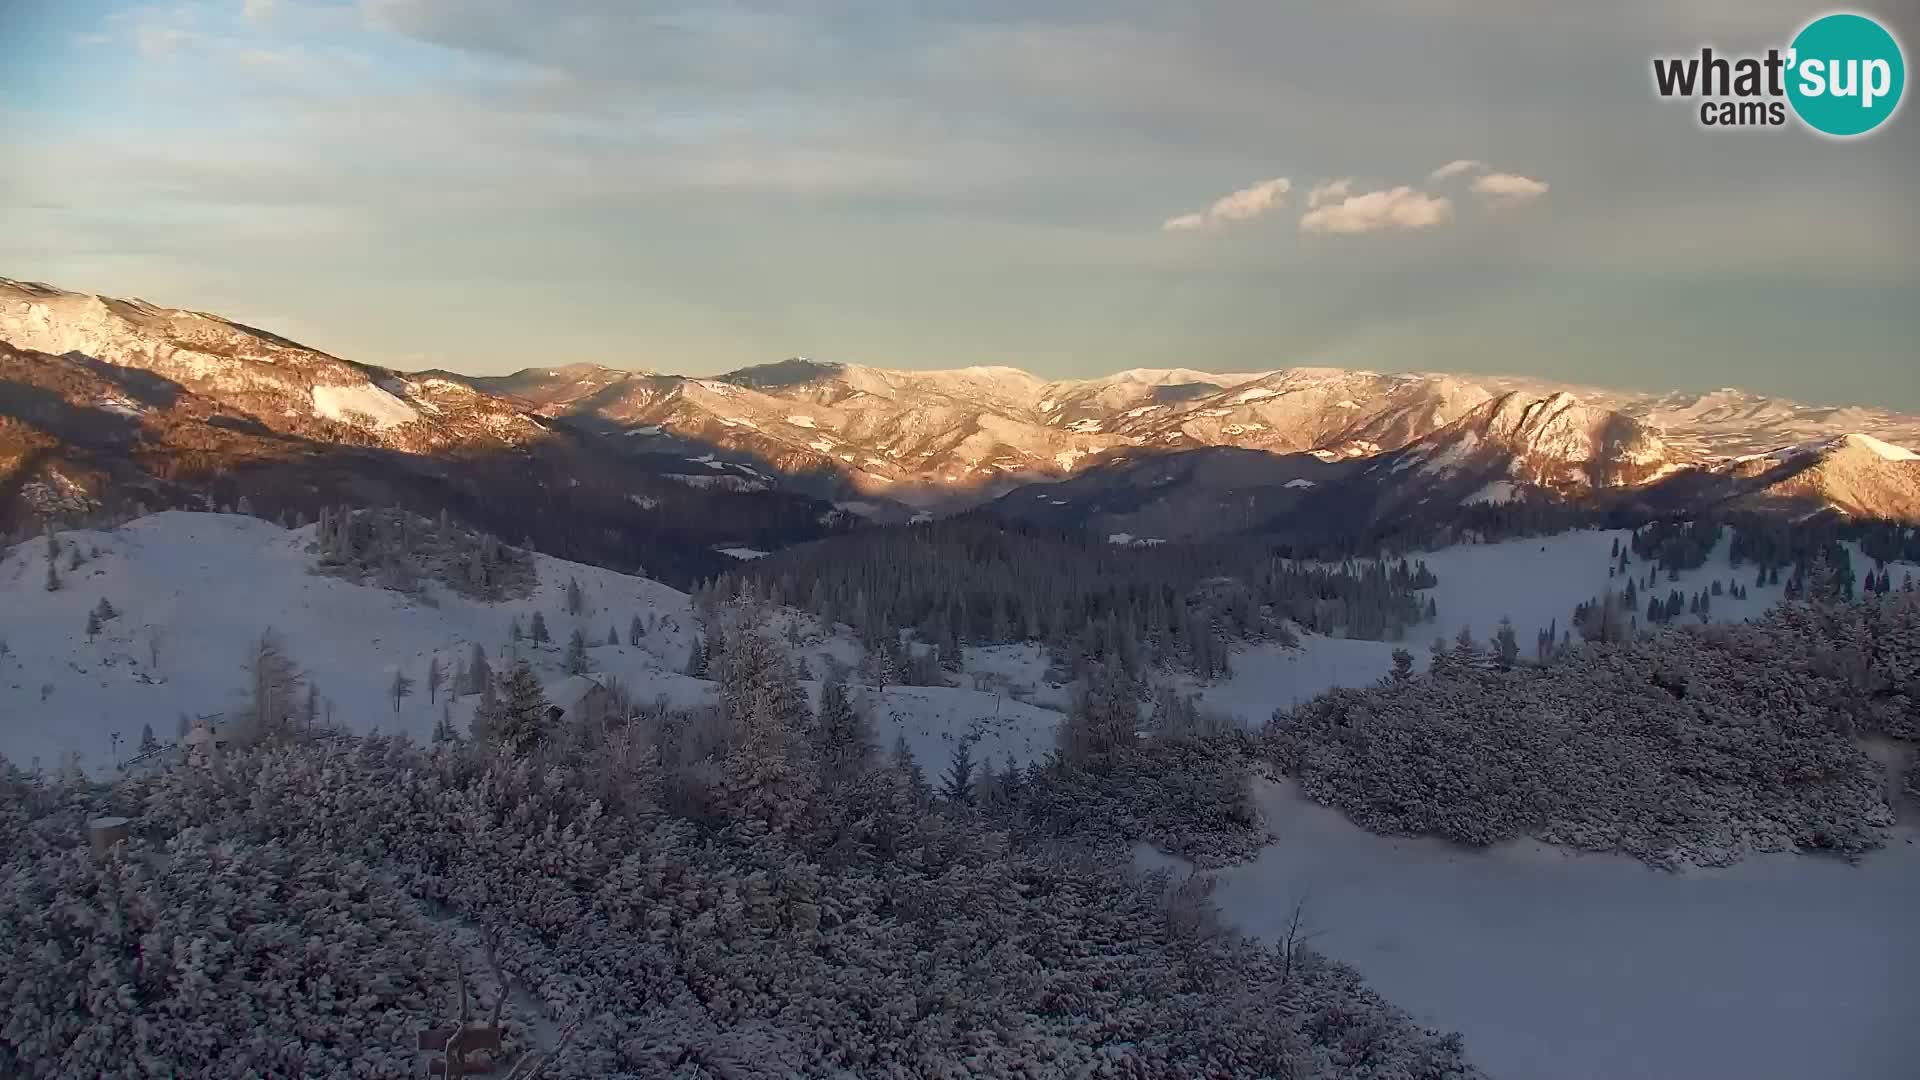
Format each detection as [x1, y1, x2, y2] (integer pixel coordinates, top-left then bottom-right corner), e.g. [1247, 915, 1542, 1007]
[0, 0, 1920, 411]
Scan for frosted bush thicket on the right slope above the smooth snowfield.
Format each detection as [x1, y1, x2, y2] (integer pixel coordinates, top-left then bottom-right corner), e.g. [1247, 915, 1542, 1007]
[1267, 594, 1920, 865]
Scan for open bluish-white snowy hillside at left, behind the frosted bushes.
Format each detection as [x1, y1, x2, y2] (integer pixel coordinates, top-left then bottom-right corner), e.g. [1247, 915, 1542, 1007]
[0, 511, 1060, 771]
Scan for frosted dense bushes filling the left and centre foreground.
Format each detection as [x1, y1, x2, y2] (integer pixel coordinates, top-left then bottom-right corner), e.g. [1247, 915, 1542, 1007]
[0, 672, 1473, 1080]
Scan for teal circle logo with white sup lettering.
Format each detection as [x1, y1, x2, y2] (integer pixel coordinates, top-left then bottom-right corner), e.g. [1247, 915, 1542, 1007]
[1788, 13, 1907, 138]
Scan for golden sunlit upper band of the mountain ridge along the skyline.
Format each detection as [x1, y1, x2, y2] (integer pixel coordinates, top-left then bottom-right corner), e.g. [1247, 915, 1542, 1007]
[11, 279, 1920, 534]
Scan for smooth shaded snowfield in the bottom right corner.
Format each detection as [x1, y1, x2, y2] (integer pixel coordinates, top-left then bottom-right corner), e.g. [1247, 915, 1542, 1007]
[1142, 782, 1920, 1080]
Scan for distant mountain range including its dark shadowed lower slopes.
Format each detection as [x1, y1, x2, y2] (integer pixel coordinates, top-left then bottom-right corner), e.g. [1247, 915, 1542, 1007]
[11, 279, 1920, 549]
